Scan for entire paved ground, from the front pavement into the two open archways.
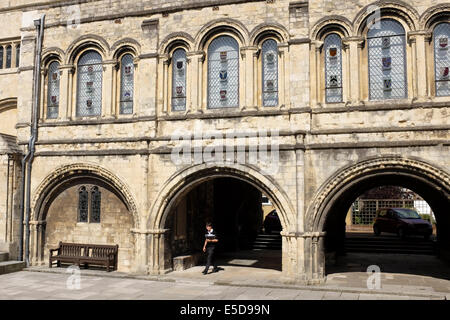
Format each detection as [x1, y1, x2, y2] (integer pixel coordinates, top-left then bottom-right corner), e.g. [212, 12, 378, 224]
[0, 253, 450, 300]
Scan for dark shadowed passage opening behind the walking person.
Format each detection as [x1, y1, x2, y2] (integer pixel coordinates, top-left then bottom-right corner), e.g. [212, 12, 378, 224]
[165, 177, 281, 273]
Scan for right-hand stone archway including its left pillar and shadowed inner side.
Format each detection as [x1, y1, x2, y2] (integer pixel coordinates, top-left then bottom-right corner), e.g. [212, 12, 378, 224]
[305, 156, 450, 279]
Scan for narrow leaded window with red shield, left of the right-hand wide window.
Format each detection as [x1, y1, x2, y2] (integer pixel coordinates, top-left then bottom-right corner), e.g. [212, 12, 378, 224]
[323, 33, 342, 103]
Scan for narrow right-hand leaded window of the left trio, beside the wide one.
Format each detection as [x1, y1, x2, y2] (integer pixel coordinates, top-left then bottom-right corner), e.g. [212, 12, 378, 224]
[120, 54, 134, 114]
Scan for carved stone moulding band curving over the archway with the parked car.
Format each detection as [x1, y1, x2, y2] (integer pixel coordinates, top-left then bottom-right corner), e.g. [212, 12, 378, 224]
[306, 155, 450, 232]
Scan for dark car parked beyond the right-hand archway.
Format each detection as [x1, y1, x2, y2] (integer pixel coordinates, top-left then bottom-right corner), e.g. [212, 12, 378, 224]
[373, 208, 433, 239]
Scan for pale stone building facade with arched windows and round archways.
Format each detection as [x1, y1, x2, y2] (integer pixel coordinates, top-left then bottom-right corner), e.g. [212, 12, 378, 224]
[0, 0, 450, 283]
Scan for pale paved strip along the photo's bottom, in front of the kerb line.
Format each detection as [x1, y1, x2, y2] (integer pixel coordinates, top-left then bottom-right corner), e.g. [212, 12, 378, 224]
[0, 271, 444, 300]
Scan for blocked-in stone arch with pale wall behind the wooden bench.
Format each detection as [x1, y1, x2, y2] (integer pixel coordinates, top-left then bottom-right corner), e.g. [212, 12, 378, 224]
[30, 164, 139, 272]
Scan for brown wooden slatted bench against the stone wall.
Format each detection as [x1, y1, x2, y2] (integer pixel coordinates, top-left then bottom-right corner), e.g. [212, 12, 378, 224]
[49, 242, 119, 272]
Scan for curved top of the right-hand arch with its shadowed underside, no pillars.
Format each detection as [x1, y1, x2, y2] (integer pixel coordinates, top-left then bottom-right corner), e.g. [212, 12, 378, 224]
[306, 156, 450, 231]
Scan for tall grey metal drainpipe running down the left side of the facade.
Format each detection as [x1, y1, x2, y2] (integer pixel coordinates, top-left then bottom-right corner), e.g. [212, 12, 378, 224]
[19, 14, 45, 267]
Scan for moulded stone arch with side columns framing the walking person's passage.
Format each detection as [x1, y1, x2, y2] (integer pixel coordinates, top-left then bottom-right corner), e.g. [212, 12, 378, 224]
[147, 164, 295, 274]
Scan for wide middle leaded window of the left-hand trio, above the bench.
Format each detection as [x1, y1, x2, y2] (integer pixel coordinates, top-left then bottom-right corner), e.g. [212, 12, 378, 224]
[77, 51, 103, 117]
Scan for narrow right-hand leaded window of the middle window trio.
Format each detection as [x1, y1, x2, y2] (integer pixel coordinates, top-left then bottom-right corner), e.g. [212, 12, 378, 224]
[262, 39, 278, 107]
